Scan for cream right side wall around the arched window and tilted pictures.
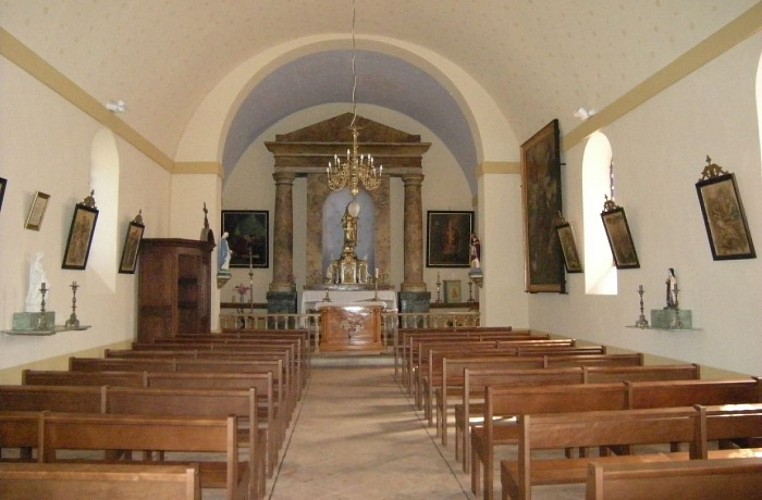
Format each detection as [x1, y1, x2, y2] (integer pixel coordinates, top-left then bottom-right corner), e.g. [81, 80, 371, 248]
[529, 35, 762, 375]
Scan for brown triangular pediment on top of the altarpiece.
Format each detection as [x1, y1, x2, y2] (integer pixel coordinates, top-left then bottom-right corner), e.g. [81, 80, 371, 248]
[275, 113, 421, 143]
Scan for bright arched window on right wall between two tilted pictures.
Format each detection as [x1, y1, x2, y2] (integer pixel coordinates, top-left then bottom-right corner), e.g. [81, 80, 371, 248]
[582, 132, 617, 295]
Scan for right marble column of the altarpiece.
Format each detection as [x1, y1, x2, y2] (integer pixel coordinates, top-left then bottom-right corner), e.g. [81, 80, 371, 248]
[400, 174, 426, 292]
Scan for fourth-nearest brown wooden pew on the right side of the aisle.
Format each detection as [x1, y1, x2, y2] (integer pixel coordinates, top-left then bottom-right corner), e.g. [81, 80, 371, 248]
[454, 360, 700, 472]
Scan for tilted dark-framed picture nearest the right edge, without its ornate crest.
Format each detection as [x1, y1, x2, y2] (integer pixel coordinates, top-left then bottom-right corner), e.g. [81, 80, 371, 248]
[696, 173, 757, 260]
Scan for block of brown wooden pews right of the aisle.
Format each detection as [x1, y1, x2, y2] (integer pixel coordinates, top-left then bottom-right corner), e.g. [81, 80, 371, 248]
[395, 327, 762, 499]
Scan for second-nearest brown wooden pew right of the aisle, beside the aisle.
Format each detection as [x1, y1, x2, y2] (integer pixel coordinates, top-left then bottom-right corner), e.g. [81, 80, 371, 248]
[500, 407, 706, 500]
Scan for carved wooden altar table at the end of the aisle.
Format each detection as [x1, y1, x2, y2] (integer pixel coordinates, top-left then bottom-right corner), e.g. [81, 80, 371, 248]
[318, 302, 383, 353]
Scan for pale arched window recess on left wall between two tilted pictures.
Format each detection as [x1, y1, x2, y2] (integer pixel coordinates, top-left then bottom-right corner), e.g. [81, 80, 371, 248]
[88, 128, 119, 291]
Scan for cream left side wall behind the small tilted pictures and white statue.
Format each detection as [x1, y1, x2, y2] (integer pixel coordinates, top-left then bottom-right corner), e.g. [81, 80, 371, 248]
[0, 58, 170, 371]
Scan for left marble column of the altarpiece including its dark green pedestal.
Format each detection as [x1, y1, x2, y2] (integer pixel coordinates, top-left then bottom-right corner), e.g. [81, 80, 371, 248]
[267, 171, 296, 313]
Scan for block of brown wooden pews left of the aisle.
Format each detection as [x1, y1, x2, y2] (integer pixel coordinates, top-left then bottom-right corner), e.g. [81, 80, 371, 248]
[0, 330, 311, 499]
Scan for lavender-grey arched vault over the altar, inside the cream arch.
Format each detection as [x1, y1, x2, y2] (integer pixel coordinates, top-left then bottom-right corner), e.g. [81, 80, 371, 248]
[222, 50, 477, 186]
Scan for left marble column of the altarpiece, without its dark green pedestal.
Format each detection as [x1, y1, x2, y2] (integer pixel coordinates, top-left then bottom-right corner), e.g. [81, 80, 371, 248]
[270, 171, 296, 292]
